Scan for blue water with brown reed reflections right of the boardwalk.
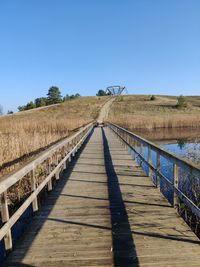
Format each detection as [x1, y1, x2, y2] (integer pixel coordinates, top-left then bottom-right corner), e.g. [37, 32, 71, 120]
[133, 129, 200, 204]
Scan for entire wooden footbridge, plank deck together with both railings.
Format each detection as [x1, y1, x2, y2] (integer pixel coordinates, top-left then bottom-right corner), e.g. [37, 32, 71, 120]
[0, 124, 200, 267]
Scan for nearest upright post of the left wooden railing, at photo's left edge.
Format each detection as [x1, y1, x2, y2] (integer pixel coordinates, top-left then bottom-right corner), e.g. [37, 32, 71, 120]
[1, 191, 12, 250]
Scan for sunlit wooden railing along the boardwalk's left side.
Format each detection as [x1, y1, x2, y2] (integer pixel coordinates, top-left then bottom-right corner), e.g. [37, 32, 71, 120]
[0, 123, 94, 250]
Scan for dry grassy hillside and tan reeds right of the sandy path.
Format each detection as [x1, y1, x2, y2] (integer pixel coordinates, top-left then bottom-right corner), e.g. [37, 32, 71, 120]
[109, 95, 200, 130]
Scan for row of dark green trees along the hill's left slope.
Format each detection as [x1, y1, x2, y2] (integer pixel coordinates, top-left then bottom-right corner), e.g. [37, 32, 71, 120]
[17, 86, 80, 112]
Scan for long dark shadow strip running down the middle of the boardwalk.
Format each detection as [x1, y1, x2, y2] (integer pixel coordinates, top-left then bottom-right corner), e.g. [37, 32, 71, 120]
[102, 128, 139, 267]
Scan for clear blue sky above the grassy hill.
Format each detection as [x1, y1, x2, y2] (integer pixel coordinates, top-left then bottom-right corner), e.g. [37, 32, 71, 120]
[0, 0, 200, 111]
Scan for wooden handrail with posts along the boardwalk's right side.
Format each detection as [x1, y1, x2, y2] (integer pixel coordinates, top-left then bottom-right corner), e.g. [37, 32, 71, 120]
[106, 122, 200, 219]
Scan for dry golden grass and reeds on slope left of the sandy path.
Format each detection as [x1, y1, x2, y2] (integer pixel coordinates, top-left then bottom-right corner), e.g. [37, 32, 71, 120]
[0, 97, 107, 175]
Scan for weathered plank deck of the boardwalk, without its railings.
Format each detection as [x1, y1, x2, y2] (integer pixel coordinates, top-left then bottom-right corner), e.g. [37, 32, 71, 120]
[5, 128, 200, 267]
